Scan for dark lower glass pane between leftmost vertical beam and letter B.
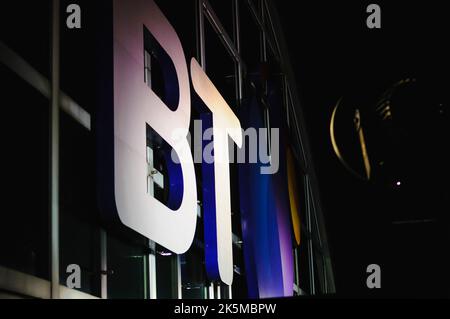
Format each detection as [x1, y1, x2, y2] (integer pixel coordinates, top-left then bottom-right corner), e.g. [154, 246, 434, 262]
[60, 113, 100, 297]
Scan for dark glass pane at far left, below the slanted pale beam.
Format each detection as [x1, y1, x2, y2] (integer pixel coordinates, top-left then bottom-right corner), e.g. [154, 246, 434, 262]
[0, 63, 49, 279]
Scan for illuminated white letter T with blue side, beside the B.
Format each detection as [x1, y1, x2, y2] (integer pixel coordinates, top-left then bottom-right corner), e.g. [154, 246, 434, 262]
[191, 59, 242, 284]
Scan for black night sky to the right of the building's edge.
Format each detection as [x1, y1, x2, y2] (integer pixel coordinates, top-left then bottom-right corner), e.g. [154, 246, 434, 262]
[277, 1, 450, 296]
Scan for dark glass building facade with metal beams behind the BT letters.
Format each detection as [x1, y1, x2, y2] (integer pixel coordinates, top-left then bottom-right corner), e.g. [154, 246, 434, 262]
[0, 0, 335, 299]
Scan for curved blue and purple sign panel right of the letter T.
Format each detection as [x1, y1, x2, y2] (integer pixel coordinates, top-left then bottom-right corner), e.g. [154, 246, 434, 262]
[239, 80, 294, 298]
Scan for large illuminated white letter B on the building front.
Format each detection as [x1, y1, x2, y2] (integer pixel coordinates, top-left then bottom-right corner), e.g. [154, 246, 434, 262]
[114, 0, 197, 254]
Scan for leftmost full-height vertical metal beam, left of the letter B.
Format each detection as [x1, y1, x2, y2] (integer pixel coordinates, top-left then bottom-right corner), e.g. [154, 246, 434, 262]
[50, 0, 59, 299]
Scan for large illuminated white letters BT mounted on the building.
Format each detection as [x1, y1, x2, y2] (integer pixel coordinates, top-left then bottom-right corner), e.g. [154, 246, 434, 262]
[99, 0, 242, 285]
